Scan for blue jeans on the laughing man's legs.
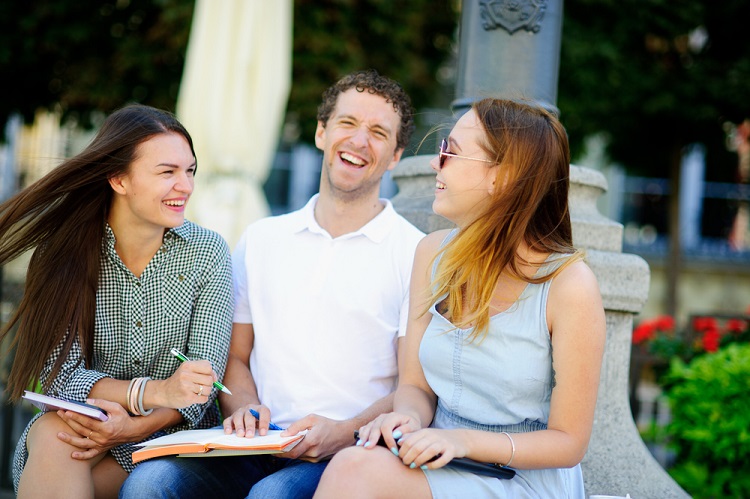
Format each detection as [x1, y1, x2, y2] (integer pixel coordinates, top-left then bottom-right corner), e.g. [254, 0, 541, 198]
[120, 455, 328, 499]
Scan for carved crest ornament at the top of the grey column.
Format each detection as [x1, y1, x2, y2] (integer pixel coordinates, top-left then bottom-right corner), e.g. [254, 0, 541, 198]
[479, 0, 547, 35]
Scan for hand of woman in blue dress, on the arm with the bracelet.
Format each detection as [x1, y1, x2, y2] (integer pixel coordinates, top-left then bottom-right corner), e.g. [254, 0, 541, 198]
[398, 428, 467, 469]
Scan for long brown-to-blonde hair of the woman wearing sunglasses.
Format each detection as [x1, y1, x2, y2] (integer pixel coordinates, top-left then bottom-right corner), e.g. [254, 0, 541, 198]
[429, 99, 579, 340]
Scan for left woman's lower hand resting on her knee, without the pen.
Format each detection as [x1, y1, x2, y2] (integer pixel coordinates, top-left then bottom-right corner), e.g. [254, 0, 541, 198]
[57, 399, 148, 460]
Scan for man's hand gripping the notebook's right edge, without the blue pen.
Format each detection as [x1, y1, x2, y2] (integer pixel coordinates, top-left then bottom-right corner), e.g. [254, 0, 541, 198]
[277, 414, 356, 462]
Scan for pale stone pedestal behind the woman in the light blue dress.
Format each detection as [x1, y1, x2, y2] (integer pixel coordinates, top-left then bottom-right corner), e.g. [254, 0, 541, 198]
[392, 155, 689, 499]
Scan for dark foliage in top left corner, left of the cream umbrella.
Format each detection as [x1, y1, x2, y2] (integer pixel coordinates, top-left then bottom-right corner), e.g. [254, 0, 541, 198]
[0, 0, 193, 129]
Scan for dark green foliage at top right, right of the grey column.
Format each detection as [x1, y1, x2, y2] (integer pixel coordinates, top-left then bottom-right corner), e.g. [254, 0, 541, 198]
[558, 0, 750, 181]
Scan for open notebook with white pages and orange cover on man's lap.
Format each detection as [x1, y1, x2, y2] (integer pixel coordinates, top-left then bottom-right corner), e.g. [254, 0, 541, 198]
[132, 428, 305, 463]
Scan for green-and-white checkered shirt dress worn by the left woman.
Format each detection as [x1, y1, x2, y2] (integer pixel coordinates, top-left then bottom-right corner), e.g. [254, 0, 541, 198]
[14, 221, 233, 488]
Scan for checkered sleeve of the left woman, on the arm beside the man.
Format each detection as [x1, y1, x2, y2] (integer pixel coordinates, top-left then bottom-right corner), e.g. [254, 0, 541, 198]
[178, 236, 233, 428]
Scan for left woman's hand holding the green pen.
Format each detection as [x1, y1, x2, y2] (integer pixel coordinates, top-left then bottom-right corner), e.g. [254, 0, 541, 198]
[152, 360, 218, 409]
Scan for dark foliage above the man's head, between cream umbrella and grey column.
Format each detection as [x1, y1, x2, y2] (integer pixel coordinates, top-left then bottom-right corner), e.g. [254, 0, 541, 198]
[288, 0, 458, 150]
